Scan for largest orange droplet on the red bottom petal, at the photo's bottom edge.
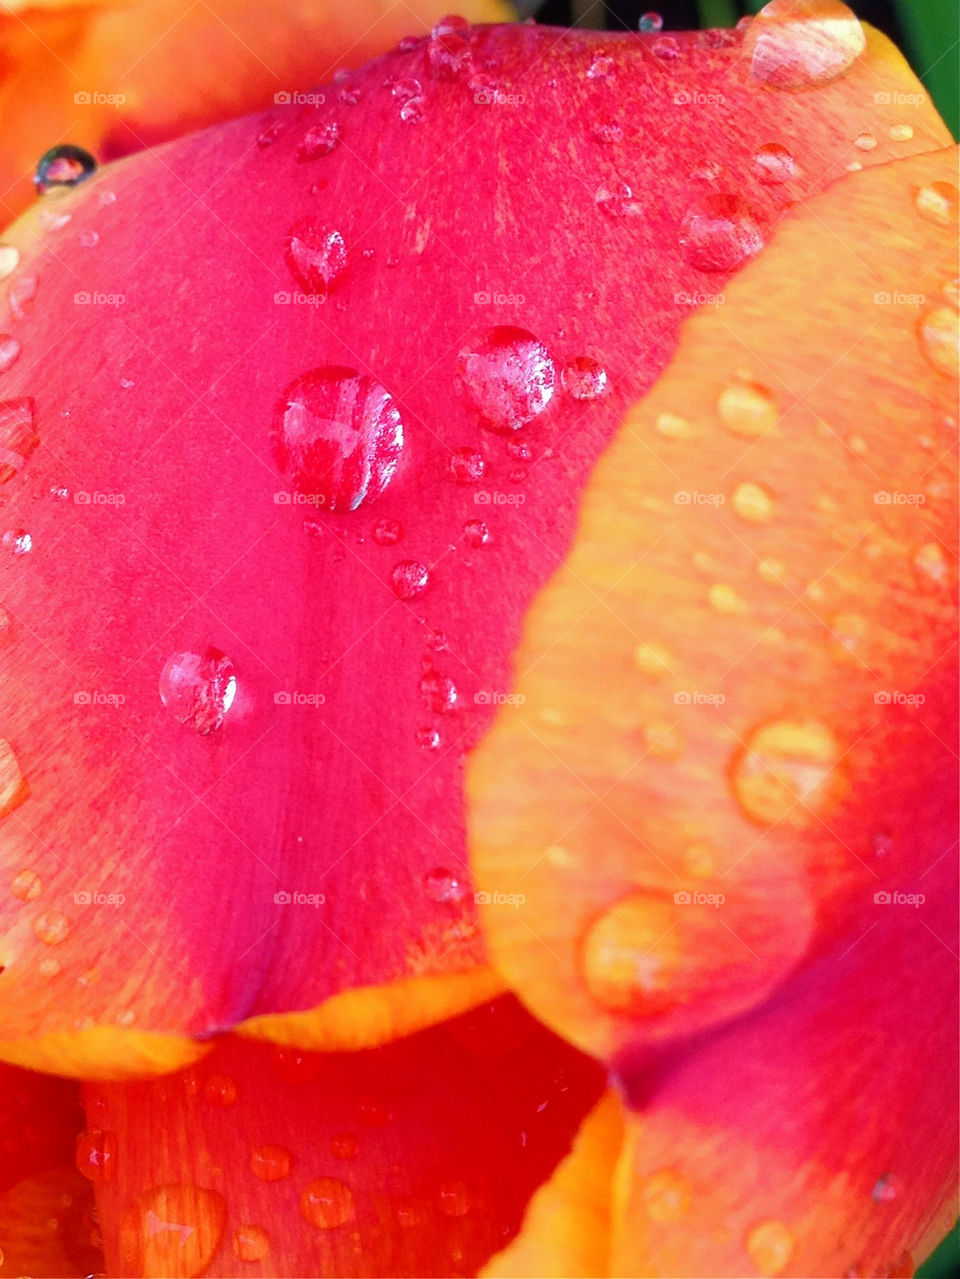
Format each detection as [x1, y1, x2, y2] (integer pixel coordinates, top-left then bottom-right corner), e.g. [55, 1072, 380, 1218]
[120, 1182, 226, 1279]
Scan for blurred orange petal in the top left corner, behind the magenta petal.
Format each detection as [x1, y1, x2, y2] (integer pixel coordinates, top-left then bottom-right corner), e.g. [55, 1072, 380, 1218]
[0, 0, 513, 220]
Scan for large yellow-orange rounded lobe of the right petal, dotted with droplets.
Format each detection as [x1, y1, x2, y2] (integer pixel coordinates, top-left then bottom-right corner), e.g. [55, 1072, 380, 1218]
[469, 142, 957, 1055]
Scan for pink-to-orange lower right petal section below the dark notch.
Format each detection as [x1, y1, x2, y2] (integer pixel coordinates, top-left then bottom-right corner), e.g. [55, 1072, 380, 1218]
[610, 853, 957, 1279]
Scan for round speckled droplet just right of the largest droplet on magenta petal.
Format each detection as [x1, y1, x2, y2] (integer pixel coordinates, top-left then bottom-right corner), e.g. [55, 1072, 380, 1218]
[459, 325, 555, 432]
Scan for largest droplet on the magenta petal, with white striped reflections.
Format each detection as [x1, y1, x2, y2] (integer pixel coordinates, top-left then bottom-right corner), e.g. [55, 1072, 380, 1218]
[275, 367, 404, 510]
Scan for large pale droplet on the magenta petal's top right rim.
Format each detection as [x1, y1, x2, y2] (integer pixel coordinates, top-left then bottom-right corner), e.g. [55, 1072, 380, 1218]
[744, 0, 867, 90]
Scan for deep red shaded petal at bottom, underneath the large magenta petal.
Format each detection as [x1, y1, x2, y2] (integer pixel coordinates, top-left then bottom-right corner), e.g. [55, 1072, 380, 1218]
[86, 999, 602, 1279]
